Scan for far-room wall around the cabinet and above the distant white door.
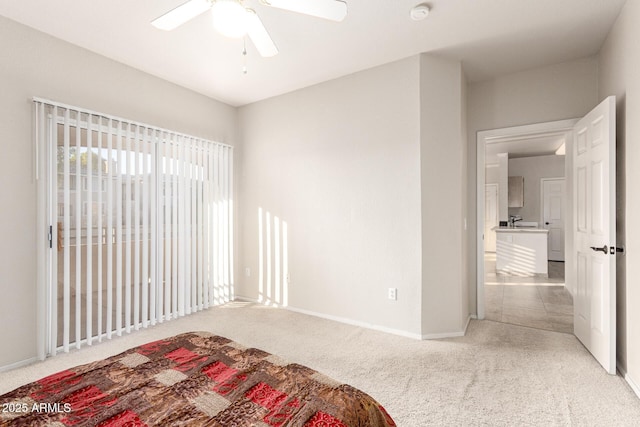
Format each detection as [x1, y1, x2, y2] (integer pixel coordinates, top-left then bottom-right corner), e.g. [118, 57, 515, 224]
[509, 156, 565, 226]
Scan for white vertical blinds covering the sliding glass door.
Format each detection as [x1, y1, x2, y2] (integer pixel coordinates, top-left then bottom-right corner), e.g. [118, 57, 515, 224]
[34, 99, 233, 358]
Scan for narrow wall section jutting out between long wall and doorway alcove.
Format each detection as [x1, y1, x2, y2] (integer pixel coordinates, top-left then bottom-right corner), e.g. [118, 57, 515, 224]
[420, 55, 475, 337]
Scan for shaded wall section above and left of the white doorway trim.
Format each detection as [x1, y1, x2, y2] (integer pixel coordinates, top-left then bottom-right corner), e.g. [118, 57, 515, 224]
[467, 57, 598, 313]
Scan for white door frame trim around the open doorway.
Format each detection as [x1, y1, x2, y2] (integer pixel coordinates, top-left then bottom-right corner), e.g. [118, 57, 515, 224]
[476, 118, 579, 319]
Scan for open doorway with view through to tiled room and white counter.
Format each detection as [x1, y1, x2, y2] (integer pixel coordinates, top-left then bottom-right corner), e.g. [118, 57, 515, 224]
[477, 120, 577, 333]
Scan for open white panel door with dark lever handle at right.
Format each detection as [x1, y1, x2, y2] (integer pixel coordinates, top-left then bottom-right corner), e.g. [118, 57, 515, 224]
[573, 96, 616, 374]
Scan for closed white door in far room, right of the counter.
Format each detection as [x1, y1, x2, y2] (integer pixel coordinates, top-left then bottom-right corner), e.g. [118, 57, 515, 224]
[542, 178, 565, 261]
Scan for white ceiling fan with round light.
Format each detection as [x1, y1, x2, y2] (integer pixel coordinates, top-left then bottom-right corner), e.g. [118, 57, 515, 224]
[151, 0, 347, 57]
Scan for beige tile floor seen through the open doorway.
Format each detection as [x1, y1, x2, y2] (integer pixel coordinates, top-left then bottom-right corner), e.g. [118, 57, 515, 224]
[484, 252, 573, 333]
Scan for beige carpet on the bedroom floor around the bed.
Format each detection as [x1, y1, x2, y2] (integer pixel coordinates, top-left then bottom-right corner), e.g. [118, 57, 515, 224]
[0, 303, 640, 427]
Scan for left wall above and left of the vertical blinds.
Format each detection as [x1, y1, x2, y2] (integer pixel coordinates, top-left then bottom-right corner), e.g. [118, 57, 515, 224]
[0, 17, 237, 367]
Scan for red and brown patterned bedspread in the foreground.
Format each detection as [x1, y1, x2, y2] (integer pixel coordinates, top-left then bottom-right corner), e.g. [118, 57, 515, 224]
[0, 332, 395, 427]
